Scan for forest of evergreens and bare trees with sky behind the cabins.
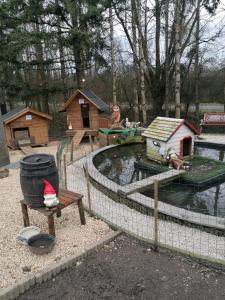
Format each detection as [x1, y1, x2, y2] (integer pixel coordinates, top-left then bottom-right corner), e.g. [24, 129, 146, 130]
[0, 0, 225, 135]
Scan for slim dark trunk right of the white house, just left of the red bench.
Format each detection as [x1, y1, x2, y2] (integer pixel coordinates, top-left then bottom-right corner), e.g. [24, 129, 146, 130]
[195, 0, 201, 121]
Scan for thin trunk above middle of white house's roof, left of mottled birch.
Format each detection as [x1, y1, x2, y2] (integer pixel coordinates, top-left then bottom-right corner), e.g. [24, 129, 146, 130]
[165, 0, 169, 117]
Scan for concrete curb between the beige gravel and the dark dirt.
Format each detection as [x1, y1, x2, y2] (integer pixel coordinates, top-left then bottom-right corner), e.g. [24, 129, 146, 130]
[0, 231, 122, 300]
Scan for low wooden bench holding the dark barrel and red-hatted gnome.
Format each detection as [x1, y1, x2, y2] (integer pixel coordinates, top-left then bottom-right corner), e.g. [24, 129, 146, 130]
[20, 189, 86, 236]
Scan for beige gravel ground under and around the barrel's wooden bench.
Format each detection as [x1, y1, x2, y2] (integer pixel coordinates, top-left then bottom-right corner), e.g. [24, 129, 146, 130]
[0, 143, 110, 288]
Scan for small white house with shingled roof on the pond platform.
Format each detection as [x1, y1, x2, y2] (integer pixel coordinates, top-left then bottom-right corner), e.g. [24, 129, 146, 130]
[142, 117, 199, 163]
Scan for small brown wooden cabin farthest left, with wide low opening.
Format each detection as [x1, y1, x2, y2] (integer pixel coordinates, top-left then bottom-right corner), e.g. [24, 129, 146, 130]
[2, 107, 52, 148]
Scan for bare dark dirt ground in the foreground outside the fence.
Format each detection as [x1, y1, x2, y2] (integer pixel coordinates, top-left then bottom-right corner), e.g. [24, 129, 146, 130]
[17, 236, 225, 300]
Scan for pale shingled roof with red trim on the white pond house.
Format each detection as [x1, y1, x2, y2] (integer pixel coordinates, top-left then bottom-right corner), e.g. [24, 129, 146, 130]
[142, 117, 199, 142]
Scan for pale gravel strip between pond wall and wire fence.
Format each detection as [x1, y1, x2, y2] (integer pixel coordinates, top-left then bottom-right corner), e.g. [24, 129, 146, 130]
[68, 159, 225, 261]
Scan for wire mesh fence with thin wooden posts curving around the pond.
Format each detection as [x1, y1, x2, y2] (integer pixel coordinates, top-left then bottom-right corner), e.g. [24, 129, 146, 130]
[58, 142, 225, 265]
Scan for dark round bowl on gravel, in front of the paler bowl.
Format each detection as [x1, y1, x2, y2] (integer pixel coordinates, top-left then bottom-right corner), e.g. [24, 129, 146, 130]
[27, 233, 55, 254]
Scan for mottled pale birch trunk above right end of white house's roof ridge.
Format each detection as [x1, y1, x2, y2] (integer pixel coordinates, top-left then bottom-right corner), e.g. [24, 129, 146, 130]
[175, 0, 181, 119]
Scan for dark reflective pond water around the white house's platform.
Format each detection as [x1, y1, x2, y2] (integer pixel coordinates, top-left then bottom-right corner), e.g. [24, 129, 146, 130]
[94, 144, 225, 217]
